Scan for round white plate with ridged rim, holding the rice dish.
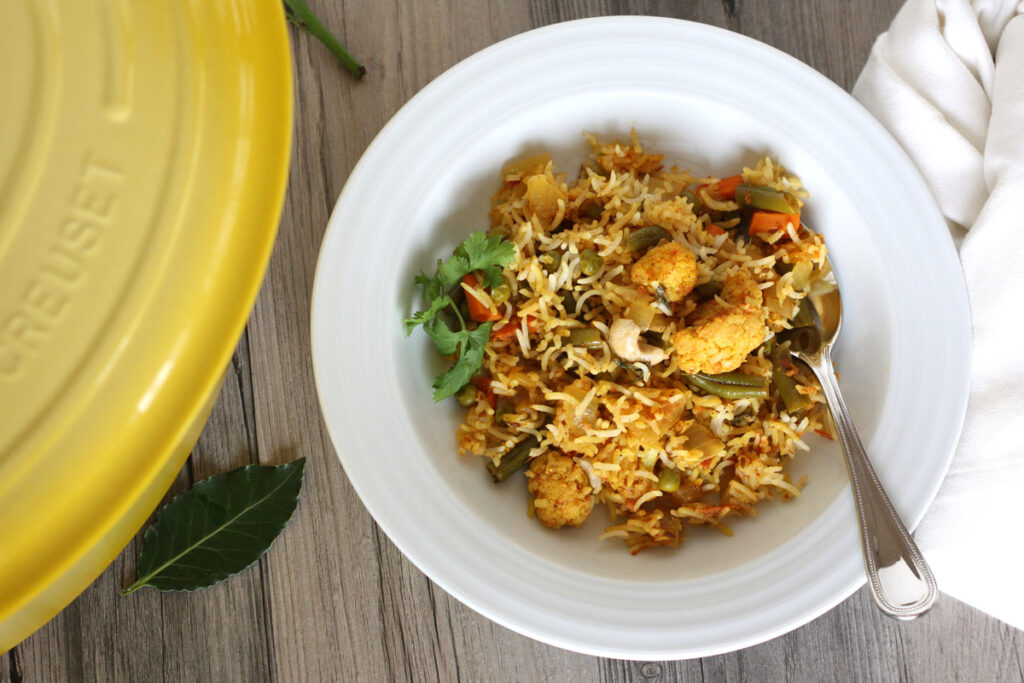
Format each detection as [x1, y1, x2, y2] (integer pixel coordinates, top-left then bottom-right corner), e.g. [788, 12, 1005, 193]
[312, 17, 970, 659]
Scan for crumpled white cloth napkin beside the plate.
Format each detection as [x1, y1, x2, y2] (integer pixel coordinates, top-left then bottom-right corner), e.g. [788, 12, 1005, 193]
[853, 0, 1024, 629]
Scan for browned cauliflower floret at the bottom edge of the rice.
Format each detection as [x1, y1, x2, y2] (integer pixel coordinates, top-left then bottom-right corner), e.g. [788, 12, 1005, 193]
[526, 451, 594, 528]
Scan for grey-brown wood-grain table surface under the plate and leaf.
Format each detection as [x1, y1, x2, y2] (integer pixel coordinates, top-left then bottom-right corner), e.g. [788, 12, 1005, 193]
[0, 0, 1024, 683]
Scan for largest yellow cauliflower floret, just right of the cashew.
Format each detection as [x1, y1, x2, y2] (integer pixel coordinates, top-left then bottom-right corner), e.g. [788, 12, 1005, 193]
[672, 301, 768, 375]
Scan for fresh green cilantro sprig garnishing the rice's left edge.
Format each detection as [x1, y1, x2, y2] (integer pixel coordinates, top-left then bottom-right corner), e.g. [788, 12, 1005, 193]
[403, 230, 515, 400]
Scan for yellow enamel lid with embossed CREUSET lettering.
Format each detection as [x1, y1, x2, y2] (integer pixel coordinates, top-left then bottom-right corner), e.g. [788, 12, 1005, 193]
[0, 0, 292, 652]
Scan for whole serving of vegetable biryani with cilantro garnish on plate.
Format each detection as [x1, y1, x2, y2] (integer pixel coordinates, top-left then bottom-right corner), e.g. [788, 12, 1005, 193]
[406, 131, 835, 553]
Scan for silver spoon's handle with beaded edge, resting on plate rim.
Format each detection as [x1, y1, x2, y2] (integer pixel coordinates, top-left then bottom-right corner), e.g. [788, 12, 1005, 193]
[802, 346, 938, 620]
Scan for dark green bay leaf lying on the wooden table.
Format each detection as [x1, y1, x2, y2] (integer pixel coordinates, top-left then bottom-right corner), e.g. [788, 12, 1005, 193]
[121, 458, 306, 595]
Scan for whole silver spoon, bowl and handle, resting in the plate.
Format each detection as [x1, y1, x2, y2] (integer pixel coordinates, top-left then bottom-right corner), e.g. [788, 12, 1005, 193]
[783, 241, 938, 620]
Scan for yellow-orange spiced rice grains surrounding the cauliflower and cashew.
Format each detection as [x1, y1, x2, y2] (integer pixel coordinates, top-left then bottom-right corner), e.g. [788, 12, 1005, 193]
[458, 132, 828, 553]
